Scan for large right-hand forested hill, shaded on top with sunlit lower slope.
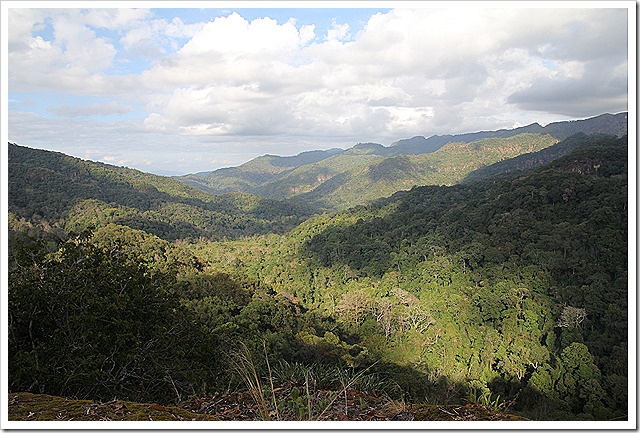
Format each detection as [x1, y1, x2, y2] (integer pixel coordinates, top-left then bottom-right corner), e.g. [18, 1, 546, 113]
[192, 132, 628, 420]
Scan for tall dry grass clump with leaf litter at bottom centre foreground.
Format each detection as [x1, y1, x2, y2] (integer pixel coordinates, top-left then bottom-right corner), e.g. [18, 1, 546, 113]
[225, 345, 522, 421]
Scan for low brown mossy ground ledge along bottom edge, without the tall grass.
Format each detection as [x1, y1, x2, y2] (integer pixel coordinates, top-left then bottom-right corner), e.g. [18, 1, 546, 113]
[8, 389, 526, 421]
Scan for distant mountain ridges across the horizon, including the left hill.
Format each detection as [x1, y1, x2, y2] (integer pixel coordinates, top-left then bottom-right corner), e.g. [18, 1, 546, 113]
[8, 113, 627, 240]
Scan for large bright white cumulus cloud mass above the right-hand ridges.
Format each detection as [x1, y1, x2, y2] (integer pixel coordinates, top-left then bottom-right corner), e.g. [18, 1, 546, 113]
[136, 8, 626, 140]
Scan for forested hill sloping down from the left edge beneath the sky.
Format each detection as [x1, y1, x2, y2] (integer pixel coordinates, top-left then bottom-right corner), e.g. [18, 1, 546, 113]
[8, 143, 311, 240]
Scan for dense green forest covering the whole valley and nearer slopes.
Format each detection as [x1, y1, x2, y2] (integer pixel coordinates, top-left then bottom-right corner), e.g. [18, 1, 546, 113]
[8, 130, 629, 420]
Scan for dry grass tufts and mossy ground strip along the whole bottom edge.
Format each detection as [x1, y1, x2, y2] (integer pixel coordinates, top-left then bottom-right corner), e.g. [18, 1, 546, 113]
[8, 344, 524, 421]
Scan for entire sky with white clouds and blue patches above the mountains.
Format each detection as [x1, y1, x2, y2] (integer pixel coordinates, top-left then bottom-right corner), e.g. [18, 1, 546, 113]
[2, 1, 635, 174]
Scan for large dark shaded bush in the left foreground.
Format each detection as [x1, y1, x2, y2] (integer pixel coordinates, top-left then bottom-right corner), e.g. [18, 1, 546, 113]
[8, 233, 219, 400]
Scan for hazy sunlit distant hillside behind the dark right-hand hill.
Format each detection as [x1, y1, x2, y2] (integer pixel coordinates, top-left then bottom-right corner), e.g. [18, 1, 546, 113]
[182, 134, 556, 210]
